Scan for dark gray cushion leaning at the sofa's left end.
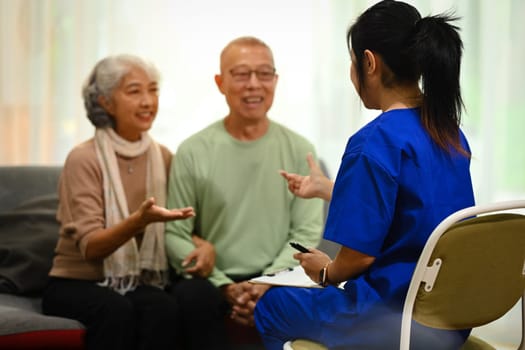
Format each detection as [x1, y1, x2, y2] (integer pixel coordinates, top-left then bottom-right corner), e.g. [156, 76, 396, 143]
[0, 194, 59, 295]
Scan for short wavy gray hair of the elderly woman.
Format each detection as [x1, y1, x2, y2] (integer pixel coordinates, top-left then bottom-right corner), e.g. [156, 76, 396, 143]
[82, 55, 160, 128]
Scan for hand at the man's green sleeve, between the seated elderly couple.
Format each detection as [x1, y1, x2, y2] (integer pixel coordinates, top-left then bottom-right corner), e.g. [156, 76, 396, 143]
[182, 235, 215, 278]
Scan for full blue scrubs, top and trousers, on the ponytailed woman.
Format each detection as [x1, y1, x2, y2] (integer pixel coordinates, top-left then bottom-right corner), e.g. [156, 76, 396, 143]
[255, 109, 474, 350]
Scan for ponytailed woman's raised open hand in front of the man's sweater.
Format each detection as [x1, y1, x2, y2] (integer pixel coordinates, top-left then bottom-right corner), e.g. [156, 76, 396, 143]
[279, 153, 333, 201]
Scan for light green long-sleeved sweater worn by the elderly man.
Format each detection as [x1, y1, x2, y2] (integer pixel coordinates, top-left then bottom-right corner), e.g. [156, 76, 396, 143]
[166, 120, 322, 286]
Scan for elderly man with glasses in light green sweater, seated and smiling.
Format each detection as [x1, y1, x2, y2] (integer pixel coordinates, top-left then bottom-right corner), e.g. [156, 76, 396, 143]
[166, 37, 322, 349]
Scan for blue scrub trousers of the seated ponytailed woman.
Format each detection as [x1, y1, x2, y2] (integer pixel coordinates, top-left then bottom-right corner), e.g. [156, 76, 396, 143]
[255, 286, 470, 350]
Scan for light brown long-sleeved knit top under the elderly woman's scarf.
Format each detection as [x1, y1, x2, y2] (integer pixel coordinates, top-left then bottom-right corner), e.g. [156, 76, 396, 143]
[49, 139, 172, 281]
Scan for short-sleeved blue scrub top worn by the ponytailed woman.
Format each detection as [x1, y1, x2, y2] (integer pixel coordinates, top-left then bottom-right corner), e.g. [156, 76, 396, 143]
[324, 109, 474, 306]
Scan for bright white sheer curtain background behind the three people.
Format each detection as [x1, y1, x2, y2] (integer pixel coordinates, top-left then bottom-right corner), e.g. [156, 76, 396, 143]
[0, 0, 525, 344]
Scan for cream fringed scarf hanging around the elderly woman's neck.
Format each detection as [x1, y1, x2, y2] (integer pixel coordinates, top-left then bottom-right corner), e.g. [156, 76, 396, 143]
[95, 128, 168, 295]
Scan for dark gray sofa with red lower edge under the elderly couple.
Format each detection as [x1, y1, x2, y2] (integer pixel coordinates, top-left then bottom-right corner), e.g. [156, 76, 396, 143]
[0, 166, 263, 350]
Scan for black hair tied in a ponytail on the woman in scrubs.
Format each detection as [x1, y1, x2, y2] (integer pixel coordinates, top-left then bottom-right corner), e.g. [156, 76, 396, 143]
[347, 0, 469, 156]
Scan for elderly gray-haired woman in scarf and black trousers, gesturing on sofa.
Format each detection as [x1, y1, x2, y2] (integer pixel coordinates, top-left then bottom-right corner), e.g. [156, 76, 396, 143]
[43, 55, 194, 349]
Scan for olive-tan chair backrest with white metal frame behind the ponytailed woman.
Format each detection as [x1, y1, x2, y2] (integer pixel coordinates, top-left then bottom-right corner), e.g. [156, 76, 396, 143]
[400, 200, 525, 350]
